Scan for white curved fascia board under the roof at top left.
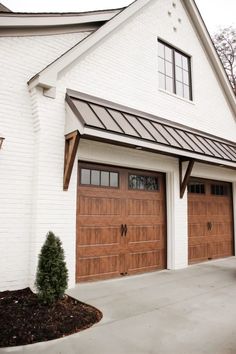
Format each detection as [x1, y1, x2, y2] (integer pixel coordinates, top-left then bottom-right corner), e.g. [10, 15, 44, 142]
[0, 10, 120, 29]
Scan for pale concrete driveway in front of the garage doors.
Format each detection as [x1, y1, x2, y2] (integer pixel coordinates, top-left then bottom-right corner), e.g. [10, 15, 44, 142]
[0, 257, 236, 354]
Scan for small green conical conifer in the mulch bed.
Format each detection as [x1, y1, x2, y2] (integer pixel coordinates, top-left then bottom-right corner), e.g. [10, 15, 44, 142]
[35, 231, 68, 304]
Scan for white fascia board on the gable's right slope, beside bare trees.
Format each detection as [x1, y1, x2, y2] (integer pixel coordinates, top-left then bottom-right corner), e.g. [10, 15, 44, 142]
[182, 0, 236, 119]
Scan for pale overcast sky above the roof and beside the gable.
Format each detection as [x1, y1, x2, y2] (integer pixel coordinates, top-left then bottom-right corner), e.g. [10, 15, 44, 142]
[0, 0, 236, 32]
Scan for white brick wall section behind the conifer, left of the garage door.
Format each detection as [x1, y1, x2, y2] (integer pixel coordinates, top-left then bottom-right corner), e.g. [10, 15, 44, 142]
[30, 90, 77, 286]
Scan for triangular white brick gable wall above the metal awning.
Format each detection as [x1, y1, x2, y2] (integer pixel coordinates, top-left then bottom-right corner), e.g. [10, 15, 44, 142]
[62, 0, 236, 140]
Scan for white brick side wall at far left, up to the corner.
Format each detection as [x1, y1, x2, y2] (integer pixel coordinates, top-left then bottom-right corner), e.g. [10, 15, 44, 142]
[0, 33, 90, 290]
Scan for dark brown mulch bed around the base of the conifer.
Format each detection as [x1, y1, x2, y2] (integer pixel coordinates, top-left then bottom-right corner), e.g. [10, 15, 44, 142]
[0, 288, 102, 347]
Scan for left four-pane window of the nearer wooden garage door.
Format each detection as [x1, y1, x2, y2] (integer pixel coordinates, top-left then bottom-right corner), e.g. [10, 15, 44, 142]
[80, 168, 119, 188]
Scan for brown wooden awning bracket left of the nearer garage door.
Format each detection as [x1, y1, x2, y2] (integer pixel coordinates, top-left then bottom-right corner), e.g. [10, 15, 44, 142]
[63, 130, 80, 191]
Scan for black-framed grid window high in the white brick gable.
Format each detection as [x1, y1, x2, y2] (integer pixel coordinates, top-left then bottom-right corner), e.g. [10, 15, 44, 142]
[158, 40, 192, 100]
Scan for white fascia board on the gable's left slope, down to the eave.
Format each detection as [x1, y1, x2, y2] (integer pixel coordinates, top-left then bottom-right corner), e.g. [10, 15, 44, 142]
[29, 0, 153, 88]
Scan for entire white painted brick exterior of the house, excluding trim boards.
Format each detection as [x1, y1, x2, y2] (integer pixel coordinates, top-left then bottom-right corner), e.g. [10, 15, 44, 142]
[0, 0, 236, 288]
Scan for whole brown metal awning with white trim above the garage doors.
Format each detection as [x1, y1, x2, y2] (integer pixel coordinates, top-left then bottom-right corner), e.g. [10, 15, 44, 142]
[66, 90, 236, 167]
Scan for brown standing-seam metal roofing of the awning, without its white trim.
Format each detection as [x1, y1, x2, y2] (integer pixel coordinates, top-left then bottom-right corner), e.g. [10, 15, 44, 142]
[66, 90, 236, 167]
